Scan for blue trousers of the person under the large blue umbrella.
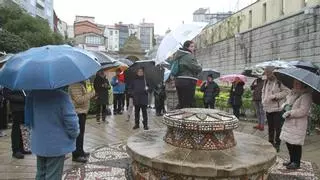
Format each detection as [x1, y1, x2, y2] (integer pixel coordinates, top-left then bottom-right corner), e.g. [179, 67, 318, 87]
[36, 155, 65, 180]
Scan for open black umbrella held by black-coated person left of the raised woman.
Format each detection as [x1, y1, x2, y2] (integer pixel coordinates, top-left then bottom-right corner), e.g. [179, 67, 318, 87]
[125, 61, 164, 89]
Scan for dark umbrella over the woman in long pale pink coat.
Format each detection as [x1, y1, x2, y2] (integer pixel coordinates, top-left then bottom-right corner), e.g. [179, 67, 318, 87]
[274, 68, 320, 104]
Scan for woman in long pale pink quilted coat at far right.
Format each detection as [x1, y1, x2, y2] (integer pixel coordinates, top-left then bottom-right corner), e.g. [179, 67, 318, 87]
[280, 80, 312, 169]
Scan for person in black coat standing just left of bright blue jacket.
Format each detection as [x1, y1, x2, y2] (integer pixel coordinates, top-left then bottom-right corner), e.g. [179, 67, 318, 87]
[93, 70, 111, 122]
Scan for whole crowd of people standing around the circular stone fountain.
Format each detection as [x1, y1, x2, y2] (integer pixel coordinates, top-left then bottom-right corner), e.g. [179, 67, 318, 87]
[1, 38, 312, 179]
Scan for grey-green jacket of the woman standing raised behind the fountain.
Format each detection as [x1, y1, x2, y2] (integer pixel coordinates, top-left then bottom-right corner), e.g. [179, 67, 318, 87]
[174, 49, 202, 80]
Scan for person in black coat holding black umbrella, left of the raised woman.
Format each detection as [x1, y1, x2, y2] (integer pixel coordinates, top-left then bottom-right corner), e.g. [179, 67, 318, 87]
[129, 68, 149, 130]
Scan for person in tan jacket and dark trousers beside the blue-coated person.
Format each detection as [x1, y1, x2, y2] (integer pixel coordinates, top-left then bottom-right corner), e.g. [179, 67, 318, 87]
[68, 82, 95, 163]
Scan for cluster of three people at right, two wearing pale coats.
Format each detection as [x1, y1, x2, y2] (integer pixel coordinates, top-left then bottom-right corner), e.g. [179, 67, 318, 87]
[251, 67, 312, 169]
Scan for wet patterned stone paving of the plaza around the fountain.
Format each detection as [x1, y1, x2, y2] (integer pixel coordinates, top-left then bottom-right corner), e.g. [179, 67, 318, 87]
[0, 110, 320, 180]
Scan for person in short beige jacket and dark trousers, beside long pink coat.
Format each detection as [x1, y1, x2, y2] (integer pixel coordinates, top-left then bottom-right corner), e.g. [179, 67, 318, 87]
[262, 67, 289, 152]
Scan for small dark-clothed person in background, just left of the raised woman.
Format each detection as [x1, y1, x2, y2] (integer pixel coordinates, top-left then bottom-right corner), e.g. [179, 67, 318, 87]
[154, 82, 166, 116]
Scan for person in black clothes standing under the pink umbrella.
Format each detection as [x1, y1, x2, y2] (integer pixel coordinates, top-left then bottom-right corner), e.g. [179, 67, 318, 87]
[229, 78, 244, 118]
